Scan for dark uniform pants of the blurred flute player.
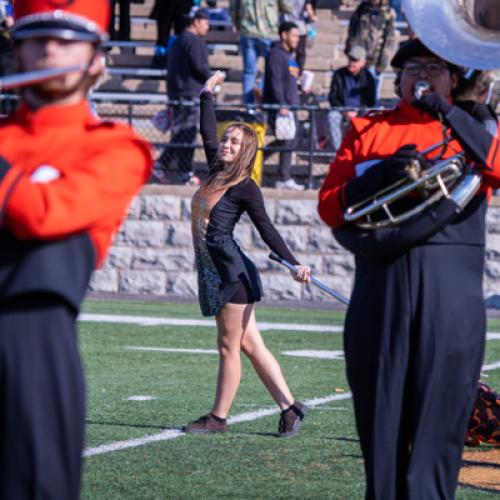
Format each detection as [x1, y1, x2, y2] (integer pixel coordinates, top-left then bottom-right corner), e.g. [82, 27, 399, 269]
[0, 294, 85, 500]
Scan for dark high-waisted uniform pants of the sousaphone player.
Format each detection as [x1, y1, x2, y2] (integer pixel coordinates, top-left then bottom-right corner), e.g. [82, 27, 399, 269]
[344, 244, 486, 500]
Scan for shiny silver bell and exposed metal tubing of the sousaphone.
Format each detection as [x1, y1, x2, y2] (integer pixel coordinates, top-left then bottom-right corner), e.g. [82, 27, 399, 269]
[344, 0, 500, 230]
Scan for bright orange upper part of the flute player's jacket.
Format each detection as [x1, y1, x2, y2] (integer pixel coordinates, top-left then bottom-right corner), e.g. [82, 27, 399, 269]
[0, 102, 152, 265]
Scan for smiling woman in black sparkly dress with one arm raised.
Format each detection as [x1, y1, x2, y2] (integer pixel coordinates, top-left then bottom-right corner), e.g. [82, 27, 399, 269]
[184, 72, 310, 437]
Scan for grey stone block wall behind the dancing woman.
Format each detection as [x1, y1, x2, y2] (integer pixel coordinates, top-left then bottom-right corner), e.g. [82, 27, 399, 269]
[90, 186, 500, 301]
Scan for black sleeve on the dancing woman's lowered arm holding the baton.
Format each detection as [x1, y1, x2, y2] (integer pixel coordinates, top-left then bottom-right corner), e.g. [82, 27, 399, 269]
[232, 180, 299, 265]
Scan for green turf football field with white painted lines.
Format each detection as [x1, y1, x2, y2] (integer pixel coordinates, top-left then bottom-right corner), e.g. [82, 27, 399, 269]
[79, 301, 500, 500]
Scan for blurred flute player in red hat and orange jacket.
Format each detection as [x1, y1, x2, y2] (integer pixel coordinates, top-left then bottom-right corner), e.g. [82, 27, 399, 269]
[0, 0, 152, 500]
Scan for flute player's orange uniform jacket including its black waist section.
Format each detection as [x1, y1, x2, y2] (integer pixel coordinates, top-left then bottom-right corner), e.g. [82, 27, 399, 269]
[0, 102, 152, 308]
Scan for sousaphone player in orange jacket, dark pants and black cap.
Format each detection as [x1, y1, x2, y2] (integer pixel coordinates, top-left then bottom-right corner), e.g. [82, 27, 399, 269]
[319, 39, 500, 500]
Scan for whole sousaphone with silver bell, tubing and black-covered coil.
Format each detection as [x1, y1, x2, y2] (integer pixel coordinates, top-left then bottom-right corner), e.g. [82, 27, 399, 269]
[333, 0, 500, 258]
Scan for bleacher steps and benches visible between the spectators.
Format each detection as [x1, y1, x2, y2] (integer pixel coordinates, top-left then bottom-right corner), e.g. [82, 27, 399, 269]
[93, 0, 404, 185]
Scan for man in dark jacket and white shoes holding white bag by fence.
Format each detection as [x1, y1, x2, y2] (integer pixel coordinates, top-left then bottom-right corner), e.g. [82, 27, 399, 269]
[264, 21, 304, 191]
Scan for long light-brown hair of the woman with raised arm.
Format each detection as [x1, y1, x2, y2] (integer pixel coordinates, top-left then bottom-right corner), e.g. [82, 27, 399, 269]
[203, 122, 258, 191]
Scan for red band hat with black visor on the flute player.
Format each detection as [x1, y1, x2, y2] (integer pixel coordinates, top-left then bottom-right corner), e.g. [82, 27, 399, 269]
[10, 0, 111, 42]
